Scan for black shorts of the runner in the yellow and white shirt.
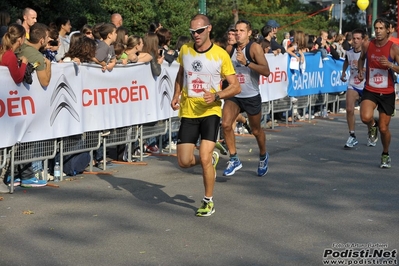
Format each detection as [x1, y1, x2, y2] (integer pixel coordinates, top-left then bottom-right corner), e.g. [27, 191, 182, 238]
[177, 115, 220, 144]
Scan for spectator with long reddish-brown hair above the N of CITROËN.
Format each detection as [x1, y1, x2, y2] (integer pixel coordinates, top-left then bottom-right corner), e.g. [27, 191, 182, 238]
[139, 33, 164, 77]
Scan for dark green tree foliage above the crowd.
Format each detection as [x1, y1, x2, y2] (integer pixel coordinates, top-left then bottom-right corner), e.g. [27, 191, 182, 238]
[0, 0, 397, 45]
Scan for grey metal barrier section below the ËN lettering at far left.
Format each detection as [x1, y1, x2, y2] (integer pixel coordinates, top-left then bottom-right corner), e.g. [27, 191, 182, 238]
[10, 139, 57, 193]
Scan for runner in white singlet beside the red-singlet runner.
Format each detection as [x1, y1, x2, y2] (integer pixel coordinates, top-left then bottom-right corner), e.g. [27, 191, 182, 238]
[341, 29, 365, 148]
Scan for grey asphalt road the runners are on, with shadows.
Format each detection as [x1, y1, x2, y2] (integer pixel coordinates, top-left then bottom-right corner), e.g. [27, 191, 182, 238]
[0, 114, 399, 266]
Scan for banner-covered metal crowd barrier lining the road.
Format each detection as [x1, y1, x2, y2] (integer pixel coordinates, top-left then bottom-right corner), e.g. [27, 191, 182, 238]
[0, 53, 346, 192]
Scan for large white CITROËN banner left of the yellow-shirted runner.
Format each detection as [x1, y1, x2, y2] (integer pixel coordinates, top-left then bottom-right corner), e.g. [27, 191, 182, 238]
[0, 63, 178, 148]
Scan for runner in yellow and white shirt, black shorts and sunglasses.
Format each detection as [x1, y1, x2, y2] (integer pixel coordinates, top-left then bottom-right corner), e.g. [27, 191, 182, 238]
[171, 14, 240, 216]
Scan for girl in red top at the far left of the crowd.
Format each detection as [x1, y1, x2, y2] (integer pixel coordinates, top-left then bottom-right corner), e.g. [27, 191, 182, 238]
[0, 24, 28, 84]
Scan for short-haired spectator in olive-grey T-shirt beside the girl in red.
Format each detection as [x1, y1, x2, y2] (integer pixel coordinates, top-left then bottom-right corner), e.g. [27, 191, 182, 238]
[17, 23, 51, 87]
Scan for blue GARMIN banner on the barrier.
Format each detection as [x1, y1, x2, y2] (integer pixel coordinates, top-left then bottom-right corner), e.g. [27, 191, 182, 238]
[288, 53, 347, 97]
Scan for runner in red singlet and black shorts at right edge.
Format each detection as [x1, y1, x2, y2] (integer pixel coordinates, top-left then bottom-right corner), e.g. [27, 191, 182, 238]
[358, 18, 399, 168]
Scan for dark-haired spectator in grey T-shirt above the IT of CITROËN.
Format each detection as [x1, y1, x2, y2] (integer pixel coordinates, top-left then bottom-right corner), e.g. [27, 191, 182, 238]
[93, 23, 116, 71]
